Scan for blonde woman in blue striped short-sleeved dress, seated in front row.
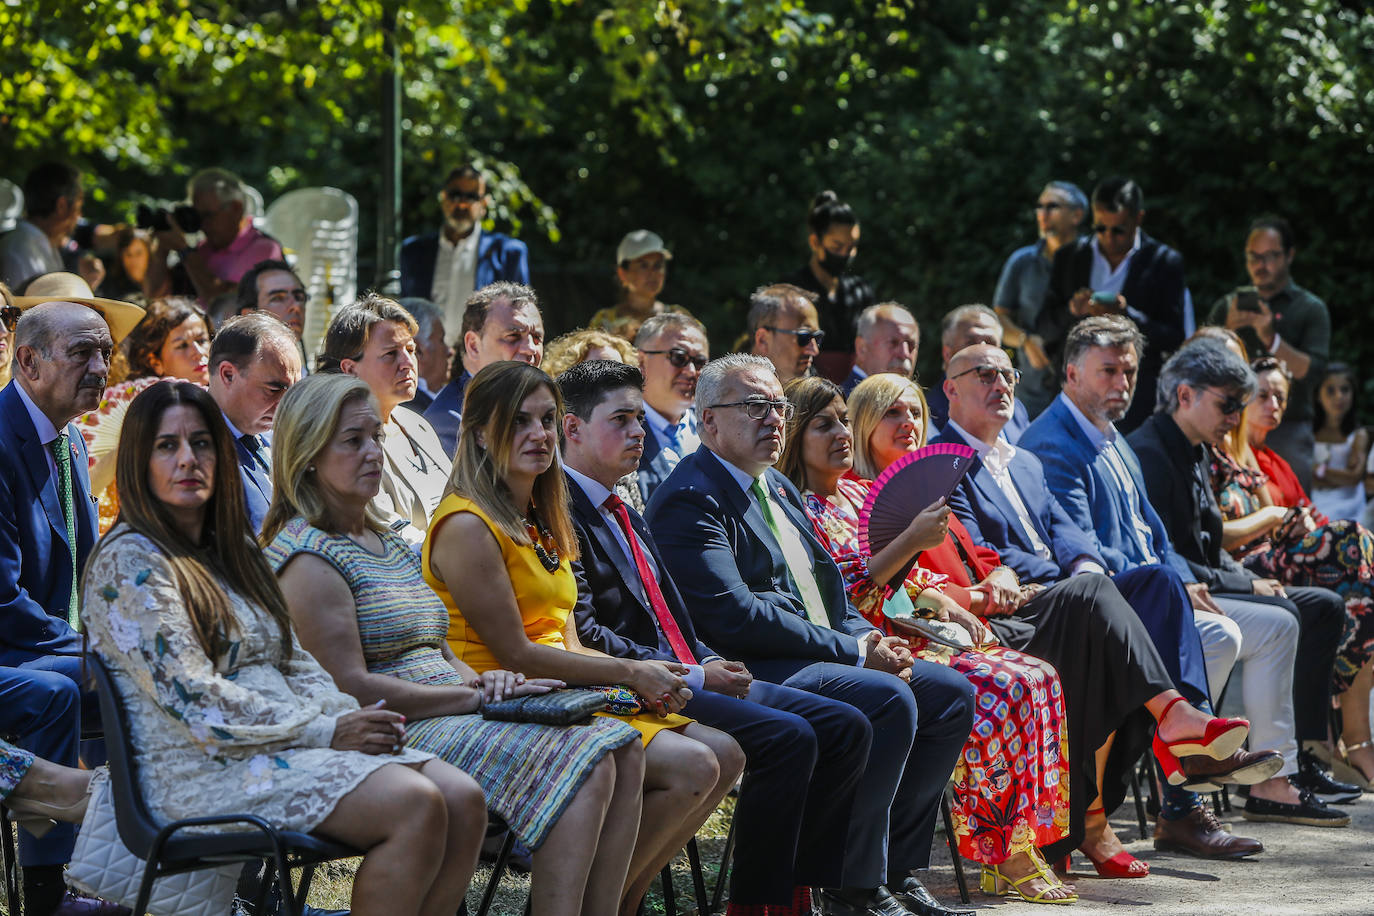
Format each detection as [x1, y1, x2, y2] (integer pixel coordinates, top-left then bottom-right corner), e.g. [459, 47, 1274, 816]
[262, 375, 643, 916]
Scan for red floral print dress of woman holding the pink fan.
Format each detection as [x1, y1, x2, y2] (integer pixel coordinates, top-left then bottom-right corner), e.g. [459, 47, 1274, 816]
[805, 478, 1069, 865]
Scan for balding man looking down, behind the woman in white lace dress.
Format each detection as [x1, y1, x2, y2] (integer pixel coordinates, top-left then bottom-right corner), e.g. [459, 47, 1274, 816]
[209, 310, 301, 531]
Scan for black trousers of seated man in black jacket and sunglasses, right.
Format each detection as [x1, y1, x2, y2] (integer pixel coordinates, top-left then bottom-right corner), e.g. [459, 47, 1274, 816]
[1232, 586, 1345, 746]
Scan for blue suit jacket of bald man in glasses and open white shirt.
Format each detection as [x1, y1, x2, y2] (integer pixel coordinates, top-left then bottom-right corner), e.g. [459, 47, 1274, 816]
[934, 428, 1106, 582]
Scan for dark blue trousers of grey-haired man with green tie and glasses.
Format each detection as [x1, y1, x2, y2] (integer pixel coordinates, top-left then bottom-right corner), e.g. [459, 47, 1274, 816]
[750, 659, 973, 887]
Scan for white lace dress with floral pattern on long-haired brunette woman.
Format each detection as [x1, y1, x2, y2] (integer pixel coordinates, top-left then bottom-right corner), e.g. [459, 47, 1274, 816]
[81, 526, 433, 831]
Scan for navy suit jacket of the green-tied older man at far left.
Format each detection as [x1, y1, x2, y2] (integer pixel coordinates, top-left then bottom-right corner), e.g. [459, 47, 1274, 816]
[0, 382, 96, 665]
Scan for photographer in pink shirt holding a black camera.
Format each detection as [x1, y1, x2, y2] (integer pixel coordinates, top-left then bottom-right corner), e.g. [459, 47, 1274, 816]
[139, 169, 282, 308]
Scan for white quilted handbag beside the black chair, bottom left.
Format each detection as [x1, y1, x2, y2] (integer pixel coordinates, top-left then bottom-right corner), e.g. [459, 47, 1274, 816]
[66, 766, 243, 916]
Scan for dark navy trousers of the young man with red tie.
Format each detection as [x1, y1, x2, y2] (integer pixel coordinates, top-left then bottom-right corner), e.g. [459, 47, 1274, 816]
[683, 681, 872, 905]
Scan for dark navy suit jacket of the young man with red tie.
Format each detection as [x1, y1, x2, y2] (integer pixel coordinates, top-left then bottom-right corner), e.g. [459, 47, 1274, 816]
[567, 478, 717, 663]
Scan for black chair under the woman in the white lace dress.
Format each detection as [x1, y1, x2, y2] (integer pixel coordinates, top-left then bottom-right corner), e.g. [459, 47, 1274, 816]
[88, 655, 363, 916]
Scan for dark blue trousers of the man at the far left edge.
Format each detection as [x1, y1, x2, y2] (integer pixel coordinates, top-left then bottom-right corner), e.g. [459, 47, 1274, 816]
[0, 659, 81, 868]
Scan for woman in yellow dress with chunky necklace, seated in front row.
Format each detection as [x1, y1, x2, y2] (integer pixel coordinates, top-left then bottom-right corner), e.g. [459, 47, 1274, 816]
[422, 361, 745, 916]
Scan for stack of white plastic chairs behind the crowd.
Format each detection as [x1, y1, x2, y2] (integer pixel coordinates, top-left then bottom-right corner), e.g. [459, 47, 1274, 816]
[264, 188, 357, 354]
